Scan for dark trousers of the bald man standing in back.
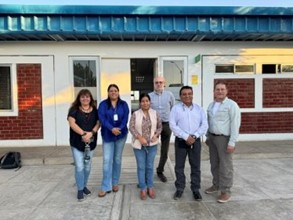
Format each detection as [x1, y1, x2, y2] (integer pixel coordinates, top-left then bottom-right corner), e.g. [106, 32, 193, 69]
[157, 122, 172, 173]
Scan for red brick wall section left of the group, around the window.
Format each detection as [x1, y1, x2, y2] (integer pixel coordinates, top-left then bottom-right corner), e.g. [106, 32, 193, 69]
[0, 64, 43, 140]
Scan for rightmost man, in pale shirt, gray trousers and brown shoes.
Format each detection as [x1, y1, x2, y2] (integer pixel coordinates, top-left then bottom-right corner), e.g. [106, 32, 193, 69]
[205, 82, 241, 203]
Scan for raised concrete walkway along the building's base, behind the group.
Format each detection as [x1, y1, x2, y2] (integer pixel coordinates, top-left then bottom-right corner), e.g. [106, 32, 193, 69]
[0, 140, 293, 166]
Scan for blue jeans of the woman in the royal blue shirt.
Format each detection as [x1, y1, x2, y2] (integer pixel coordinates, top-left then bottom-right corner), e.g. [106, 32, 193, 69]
[101, 136, 127, 192]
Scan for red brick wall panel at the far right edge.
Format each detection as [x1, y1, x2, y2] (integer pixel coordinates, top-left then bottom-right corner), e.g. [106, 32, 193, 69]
[263, 78, 293, 108]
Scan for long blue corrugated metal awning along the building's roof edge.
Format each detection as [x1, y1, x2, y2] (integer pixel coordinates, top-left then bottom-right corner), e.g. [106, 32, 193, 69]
[0, 5, 293, 41]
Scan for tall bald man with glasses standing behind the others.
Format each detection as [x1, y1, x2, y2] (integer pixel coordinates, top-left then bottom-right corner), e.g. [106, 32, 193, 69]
[149, 76, 175, 182]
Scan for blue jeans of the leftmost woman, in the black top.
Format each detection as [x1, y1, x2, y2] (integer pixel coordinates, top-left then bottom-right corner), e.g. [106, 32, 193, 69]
[71, 147, 94, 190]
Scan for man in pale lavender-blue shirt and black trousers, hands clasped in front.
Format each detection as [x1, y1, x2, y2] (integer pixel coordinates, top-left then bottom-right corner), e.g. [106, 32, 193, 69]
[170, 86, 208, 201]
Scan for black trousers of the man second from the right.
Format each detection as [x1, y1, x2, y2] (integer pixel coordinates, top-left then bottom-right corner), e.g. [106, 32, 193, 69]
[175, 137, 201, 192]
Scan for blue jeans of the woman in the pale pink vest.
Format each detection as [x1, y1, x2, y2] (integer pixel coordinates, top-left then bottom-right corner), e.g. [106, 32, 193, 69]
[133, 145, 157, 190]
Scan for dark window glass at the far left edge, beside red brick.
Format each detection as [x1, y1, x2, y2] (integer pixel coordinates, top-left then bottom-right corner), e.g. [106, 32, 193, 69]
[0, 66, 12, 110]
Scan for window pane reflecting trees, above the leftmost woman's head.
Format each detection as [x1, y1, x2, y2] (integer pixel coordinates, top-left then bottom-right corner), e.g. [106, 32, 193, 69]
[73, 60, 97, 87]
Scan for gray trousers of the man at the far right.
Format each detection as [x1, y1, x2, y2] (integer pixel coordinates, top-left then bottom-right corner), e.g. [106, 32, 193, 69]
[209, 135, 233, 193]
